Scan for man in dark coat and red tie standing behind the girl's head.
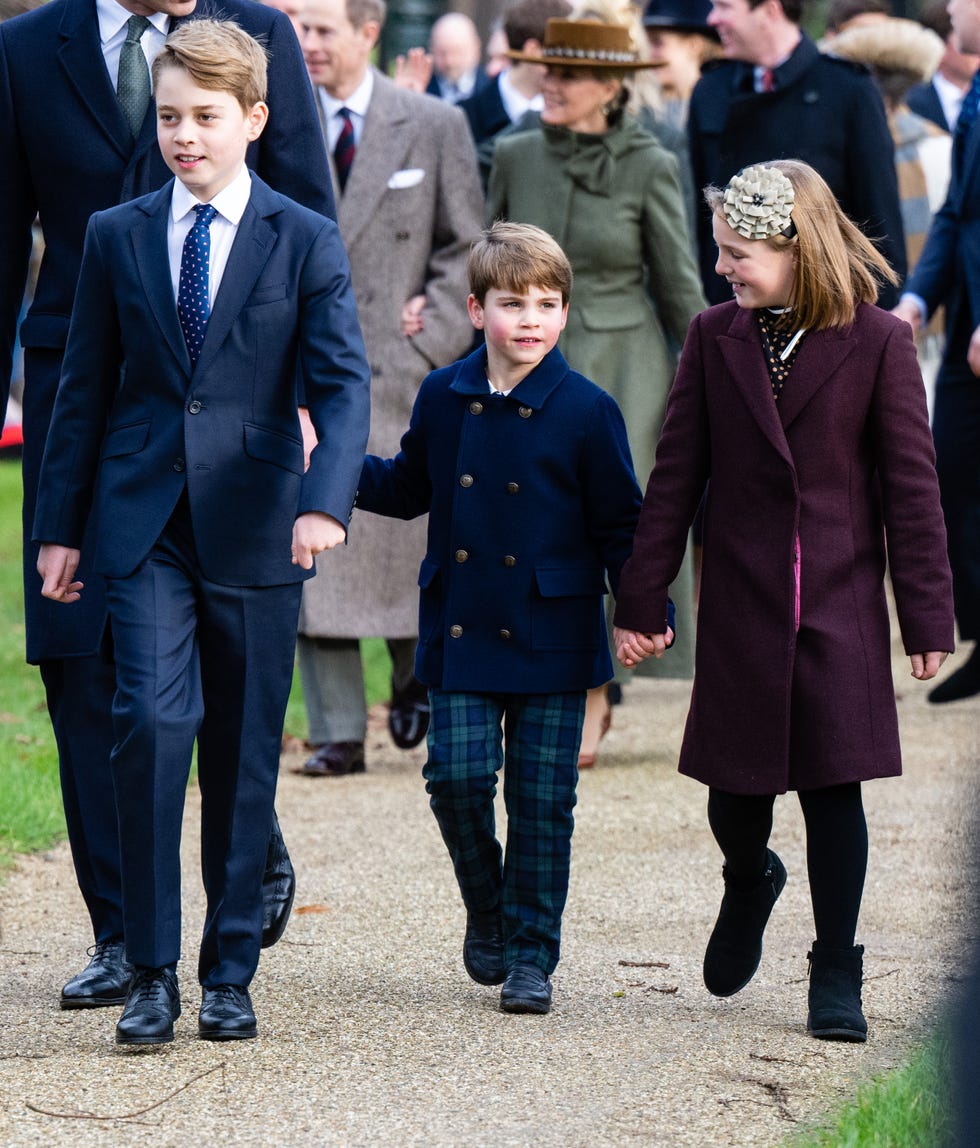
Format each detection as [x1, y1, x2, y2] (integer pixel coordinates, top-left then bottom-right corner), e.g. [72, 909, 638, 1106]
[687, 0, 905, 305]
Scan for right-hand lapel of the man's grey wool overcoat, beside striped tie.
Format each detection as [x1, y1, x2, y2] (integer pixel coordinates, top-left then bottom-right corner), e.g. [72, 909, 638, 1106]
[337, 72, 415, 248]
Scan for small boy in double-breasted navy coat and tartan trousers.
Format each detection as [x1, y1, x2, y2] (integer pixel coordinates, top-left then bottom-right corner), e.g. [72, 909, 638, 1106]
[357, 223, 667, 1013]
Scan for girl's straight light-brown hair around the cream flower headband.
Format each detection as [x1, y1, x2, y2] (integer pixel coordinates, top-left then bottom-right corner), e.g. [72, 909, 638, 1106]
[705, 160, 899, 331]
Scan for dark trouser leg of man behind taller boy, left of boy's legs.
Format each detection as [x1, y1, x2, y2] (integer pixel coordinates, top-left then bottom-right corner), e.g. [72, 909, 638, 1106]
[40, 647, 123, 941]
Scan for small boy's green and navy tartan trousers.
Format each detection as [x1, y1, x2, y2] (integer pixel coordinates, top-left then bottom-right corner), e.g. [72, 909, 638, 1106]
[422, 689, 585, 974]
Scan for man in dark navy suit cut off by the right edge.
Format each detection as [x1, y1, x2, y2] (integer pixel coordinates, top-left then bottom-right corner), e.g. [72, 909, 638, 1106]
[895, 0, 980, 703]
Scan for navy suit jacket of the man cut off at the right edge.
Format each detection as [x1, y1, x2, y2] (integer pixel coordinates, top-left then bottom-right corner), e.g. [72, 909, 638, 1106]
[905, 121, 980, 358]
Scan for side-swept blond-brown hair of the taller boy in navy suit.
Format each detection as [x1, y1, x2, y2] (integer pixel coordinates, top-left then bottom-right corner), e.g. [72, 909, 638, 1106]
[153, 20, 269, 111]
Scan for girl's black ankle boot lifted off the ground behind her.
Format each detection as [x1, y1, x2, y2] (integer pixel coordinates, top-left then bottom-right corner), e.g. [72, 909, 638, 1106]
[703, 850, 786, 996]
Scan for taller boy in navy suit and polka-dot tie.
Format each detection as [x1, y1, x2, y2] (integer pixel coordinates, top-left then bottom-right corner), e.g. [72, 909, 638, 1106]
[34, 20, 368, 1045]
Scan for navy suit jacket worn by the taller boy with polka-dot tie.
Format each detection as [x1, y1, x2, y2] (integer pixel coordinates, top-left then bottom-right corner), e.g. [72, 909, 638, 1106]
[34, 176, 370, 587]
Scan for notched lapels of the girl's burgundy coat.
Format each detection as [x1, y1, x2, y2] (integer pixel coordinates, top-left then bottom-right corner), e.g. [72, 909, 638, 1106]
[718, 303, 857, 463]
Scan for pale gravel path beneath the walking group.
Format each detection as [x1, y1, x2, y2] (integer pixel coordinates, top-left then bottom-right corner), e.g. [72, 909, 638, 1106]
[0, 657, 980, 1148]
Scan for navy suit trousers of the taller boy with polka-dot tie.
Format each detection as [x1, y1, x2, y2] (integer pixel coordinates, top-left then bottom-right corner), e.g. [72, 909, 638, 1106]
[107, 499, 301, 986]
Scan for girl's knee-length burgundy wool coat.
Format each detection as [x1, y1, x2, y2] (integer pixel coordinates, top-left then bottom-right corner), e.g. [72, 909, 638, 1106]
[615, 302, 954, 793]
